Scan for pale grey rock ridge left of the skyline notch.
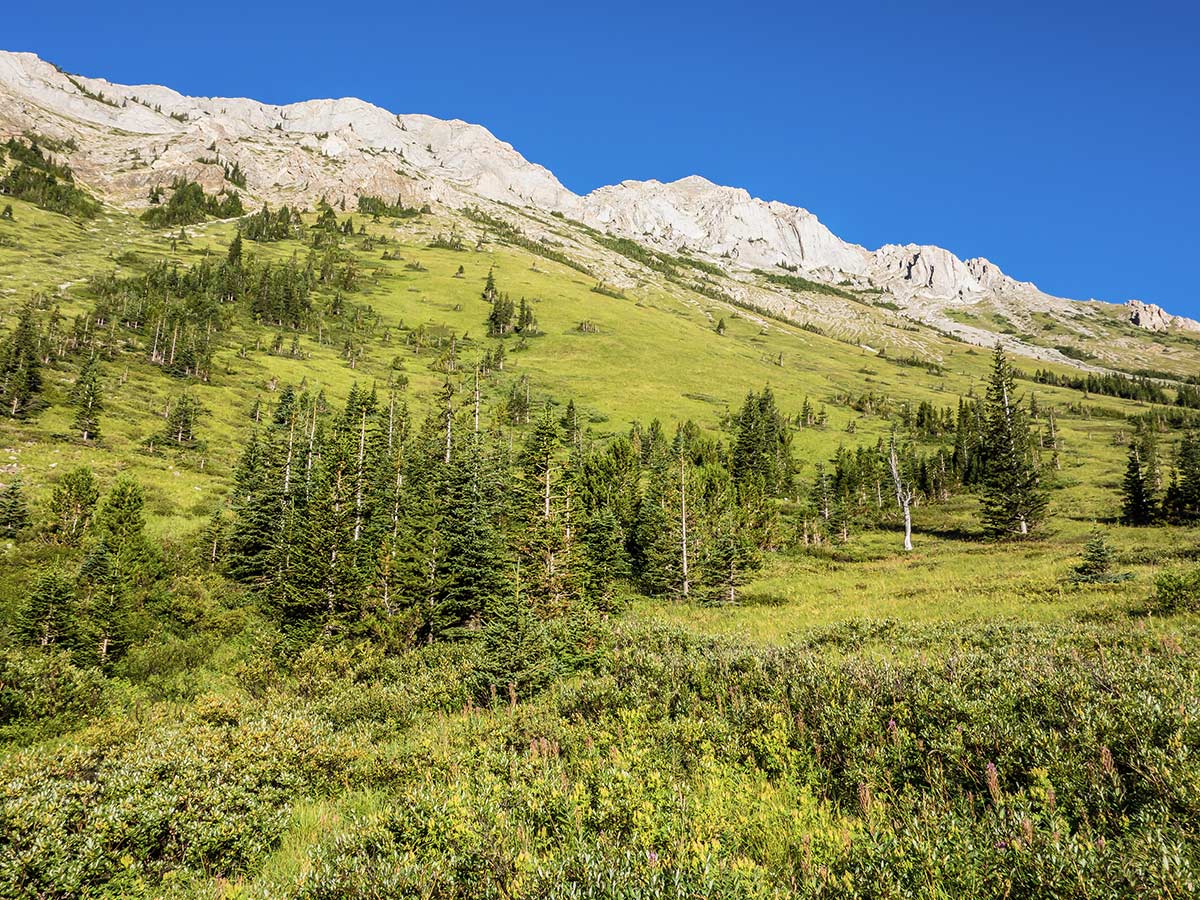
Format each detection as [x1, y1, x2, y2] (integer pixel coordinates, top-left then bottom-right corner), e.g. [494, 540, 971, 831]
[0, 52, 577, 210]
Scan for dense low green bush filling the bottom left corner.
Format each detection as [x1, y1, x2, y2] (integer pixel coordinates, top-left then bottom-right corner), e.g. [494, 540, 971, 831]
[0, 698, 364, 898]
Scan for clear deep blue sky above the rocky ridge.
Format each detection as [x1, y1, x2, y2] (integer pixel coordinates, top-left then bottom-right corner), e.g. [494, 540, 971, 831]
[9, 0, 1200, 317]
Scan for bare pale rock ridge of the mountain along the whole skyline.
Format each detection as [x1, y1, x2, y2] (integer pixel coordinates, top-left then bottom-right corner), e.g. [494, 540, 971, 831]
[0, 52, 1200, 365]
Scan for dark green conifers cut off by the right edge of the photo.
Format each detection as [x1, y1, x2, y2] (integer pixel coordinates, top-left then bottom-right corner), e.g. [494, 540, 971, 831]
[1121, 427, 1200, 526]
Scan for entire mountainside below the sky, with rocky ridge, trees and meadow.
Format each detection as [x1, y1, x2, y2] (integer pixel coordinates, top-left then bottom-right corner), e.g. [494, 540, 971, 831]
[0, 47, 1200, 900]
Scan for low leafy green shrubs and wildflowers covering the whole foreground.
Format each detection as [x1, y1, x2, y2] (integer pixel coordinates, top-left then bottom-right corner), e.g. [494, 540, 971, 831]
[0, 619, 1200, 898]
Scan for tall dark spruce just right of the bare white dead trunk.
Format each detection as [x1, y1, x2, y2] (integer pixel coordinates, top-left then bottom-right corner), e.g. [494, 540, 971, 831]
[982, 344, 1048, 538]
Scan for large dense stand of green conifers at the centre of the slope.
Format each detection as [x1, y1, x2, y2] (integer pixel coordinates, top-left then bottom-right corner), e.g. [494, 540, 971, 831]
[211, 383, 790, 643]
